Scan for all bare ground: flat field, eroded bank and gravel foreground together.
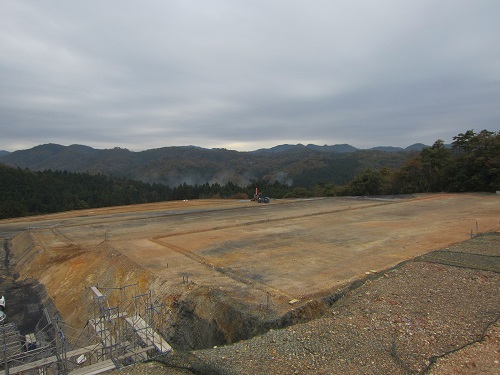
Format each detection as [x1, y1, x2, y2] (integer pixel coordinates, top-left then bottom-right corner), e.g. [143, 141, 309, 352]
[0, 194, 500, 374]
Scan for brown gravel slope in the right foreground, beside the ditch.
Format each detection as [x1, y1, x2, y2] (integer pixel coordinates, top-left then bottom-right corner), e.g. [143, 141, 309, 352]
[113, 233, 500, 374]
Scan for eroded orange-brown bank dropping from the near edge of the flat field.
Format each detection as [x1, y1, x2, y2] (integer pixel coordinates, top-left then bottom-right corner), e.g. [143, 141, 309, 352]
[7, 231, 338, 350]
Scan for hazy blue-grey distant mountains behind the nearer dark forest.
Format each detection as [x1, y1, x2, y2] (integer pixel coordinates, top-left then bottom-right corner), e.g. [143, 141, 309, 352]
[0, 143, 426, 187]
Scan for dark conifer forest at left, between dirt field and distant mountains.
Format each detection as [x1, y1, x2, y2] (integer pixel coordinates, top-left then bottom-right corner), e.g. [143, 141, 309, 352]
[0, 164, 169, 219]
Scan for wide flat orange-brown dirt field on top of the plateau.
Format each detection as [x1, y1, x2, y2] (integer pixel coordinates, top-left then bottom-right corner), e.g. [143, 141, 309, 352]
[0, 194, 500, 313]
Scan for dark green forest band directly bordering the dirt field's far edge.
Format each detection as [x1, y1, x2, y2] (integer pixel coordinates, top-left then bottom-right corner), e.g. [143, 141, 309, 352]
[0, 130, 500, 219]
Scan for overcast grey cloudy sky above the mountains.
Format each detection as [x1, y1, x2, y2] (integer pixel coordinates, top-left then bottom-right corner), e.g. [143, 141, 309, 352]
[0, 0, 500, 151]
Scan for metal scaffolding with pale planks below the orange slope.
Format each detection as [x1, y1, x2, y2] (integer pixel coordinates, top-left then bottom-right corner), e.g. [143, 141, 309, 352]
[0, 284, 172, 375]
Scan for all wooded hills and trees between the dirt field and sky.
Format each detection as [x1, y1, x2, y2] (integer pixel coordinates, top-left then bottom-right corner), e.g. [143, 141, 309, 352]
[0, 130, 500, 218]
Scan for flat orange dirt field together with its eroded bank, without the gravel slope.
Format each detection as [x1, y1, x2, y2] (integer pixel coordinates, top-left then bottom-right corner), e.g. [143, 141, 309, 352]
[0, 194, 500, 374]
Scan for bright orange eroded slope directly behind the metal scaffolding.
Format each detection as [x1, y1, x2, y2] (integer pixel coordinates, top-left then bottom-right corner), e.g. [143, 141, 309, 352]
[10, 231, 149, 327]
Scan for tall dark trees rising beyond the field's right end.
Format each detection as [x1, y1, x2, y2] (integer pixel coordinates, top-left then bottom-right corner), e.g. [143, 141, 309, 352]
[346, 130, 500, 195]
